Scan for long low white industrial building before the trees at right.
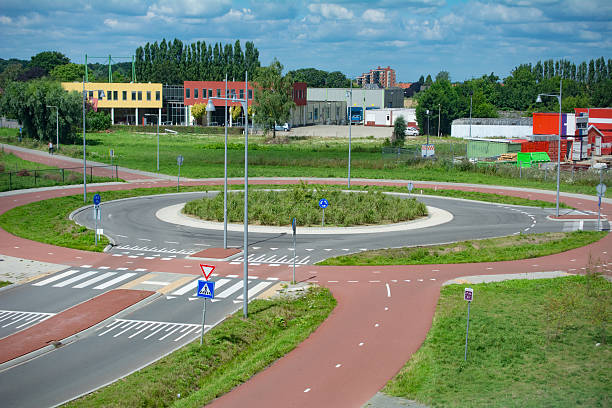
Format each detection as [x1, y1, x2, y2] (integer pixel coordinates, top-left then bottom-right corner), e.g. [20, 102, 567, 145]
[451, 118, 533, 139]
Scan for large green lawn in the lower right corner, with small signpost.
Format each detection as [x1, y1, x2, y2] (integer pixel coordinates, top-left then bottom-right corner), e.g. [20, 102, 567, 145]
[383, 274, 612, 407]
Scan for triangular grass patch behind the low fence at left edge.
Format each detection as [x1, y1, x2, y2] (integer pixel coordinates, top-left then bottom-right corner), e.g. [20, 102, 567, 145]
[0, 152, 116, 191]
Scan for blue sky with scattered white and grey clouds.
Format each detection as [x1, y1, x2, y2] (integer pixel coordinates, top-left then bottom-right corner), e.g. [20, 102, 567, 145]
[0, 0, 612, 82]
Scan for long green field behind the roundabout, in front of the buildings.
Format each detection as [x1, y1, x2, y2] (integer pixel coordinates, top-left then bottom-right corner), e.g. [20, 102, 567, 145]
[0, 128, 612, 197]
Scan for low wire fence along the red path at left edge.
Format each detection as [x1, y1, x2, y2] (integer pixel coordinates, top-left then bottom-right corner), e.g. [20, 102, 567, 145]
[0, 164, 119, 191]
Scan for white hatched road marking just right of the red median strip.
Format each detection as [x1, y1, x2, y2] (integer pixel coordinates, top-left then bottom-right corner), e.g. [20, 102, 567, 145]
[96, 319, 202, 342]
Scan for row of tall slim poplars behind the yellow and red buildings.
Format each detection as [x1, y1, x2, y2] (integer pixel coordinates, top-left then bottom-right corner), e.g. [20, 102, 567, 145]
[136, 38, 260, 84]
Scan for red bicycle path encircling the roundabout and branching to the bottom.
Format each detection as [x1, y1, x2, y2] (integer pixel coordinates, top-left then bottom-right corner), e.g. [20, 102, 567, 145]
[0, 151, 612, 407]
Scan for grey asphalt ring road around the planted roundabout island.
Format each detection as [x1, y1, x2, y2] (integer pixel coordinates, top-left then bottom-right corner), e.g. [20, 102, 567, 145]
[74, 193, 595, 265]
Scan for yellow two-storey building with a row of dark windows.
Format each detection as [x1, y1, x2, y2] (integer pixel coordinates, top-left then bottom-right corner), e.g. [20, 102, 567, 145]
[62, 82, 163, 125]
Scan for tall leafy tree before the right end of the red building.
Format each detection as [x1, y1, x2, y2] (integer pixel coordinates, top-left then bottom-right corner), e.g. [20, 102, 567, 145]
[255, 59, 295, 137]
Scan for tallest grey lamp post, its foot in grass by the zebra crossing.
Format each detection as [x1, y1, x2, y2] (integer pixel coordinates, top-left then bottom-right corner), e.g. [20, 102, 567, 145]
[206, 72, 249, 318]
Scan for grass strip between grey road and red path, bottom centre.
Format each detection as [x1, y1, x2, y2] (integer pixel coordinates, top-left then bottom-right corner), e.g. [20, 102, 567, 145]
[66, 288, 336, 408]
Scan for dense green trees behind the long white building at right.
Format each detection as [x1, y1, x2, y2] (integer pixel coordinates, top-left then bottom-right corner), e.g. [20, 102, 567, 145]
[413, 57, 612, 134]
